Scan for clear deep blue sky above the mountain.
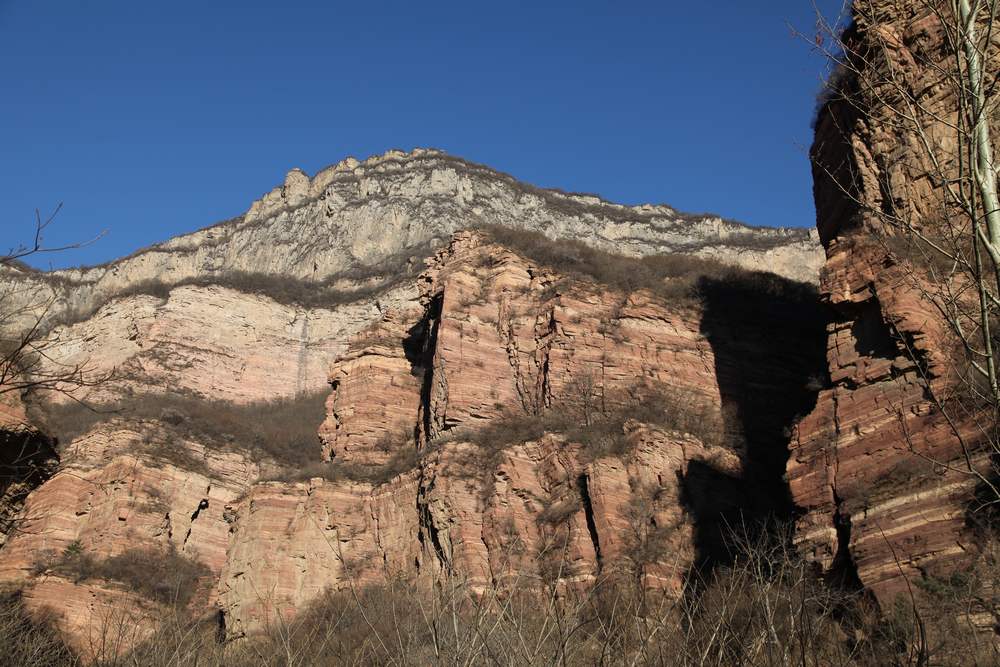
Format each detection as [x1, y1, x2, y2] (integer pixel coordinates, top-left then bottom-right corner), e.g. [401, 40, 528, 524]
[0, 0, 840, 266]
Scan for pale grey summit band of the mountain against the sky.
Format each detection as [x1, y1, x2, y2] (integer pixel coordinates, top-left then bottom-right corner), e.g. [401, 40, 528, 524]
[4, 149, 823, 332]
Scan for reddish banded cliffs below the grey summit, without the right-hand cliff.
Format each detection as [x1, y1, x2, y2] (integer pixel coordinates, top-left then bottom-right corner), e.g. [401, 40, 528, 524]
[0, 232, 823, 652]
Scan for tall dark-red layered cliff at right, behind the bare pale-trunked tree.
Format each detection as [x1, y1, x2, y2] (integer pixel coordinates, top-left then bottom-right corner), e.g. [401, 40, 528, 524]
[788, 2, 986, 604]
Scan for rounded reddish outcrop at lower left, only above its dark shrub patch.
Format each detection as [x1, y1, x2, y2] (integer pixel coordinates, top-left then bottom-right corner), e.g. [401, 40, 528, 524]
[0, 421, 259, 580]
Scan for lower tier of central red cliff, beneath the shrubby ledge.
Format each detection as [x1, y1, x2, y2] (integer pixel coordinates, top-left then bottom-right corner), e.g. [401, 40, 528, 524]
[219, 423, 741, 636]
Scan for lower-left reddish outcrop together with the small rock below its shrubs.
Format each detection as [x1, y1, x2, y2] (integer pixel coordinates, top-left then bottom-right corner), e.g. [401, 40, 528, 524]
[0, 421, 259, 657]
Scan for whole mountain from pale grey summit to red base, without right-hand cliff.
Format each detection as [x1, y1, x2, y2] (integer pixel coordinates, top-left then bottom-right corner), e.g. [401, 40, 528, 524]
[0, 150, 822, 657]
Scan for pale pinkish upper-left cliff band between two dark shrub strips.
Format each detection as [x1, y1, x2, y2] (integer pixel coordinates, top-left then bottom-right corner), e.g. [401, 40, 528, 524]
[35, 285, 416, 403]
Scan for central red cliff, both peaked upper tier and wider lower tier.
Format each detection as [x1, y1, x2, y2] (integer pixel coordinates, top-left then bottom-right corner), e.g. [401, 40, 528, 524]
[220, 233, 822, 635]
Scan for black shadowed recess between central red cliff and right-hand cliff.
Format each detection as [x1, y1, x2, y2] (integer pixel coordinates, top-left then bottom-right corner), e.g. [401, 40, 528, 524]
[685, 272, 830, 563]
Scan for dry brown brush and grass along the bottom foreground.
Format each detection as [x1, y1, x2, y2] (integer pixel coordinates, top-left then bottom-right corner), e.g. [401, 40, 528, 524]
[11, 531, 1000, 667]
